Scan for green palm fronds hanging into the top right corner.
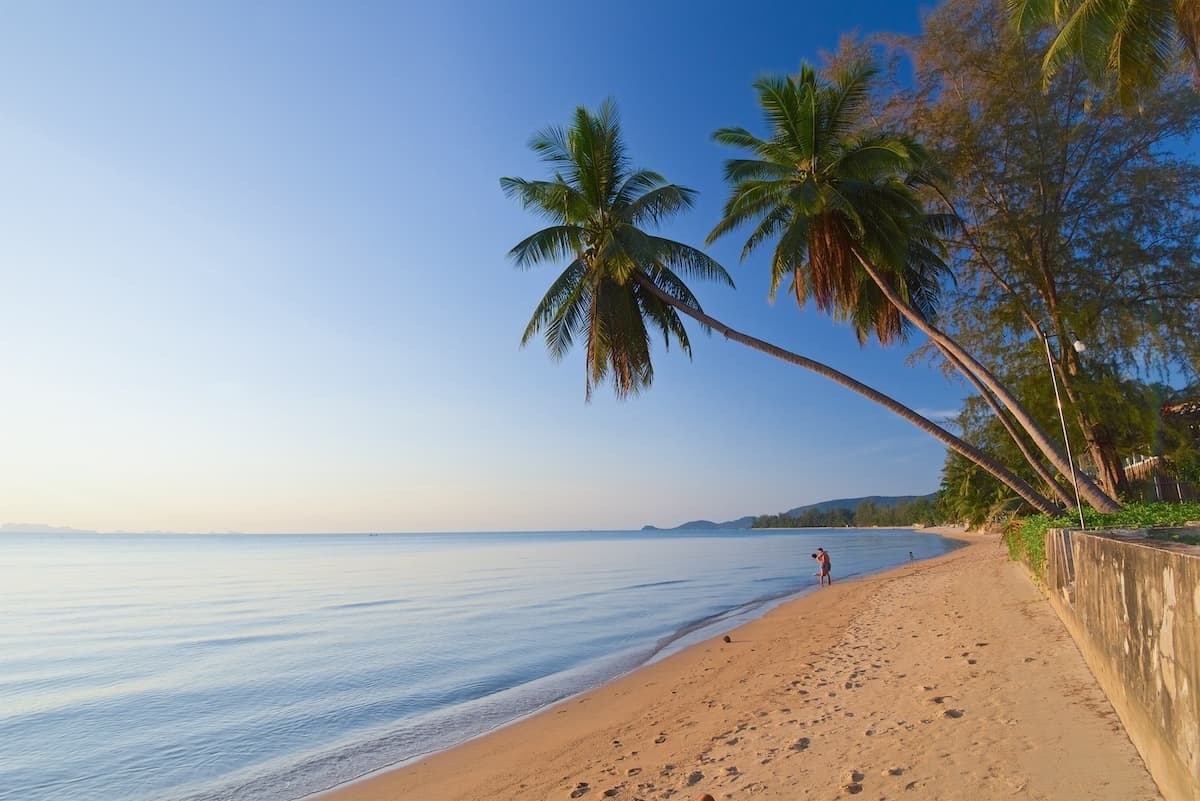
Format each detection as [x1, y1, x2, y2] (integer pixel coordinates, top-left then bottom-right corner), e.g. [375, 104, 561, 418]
[1006, 0, 1200, 103]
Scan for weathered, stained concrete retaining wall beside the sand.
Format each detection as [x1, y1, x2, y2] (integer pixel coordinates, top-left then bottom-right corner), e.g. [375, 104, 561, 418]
[1045, 529, 1200, 801]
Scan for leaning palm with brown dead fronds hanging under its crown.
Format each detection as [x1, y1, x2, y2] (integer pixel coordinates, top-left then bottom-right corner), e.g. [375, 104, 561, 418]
[708, 59, 1120, 512]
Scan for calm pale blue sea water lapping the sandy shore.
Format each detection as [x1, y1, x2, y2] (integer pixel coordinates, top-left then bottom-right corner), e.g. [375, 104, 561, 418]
[0, 529, 955, 801]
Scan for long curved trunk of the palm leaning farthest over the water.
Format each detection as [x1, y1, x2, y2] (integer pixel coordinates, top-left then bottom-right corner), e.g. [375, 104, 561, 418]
[634, 272, 1061, 514]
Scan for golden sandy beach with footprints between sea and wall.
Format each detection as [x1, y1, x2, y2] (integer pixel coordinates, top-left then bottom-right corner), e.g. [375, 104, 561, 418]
[319, 535, 1159, 801]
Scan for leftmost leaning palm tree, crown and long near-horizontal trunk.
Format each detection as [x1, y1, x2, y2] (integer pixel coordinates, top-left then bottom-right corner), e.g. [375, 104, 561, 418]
[500, 101, 1058, 512]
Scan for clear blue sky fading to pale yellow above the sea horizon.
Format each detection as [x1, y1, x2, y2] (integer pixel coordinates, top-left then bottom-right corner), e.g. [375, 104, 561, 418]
[0, 0, 962, 531]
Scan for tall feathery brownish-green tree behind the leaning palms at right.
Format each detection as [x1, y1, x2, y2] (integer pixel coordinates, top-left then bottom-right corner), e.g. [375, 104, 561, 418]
[883, 0, 1200, 494]
